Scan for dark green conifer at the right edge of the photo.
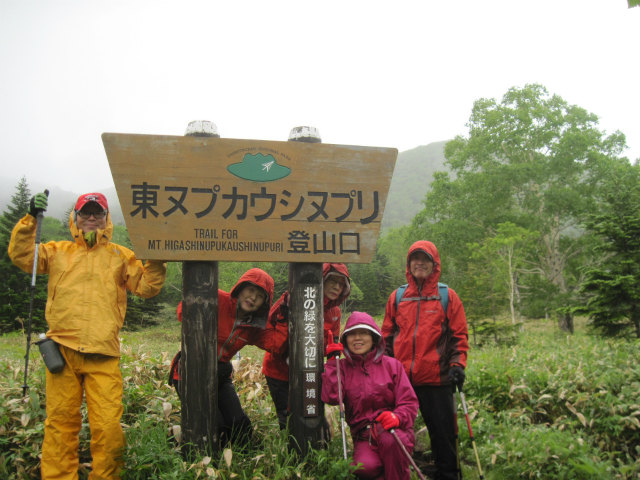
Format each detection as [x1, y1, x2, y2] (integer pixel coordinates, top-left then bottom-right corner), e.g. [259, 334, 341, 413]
[574, 164, 640, 338]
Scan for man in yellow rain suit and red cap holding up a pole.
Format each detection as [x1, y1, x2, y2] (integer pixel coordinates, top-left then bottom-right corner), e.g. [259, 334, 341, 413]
[9, 193, 166, 480]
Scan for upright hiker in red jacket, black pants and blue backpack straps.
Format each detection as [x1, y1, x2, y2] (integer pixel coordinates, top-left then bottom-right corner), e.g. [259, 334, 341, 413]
[382, 240, 469, 479]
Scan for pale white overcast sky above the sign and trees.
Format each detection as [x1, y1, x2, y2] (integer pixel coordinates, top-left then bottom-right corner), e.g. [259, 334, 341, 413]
[0, 0, 640, 193]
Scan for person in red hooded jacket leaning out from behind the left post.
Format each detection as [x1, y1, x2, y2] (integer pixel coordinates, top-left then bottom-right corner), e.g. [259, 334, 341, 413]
[169, 268, 288, 445]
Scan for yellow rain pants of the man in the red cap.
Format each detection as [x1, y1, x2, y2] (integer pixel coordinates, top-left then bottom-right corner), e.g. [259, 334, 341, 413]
[41, 345, 124, 480]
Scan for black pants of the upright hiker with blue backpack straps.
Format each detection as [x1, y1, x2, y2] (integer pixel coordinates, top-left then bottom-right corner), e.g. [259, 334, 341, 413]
[413, 385, 459, 480]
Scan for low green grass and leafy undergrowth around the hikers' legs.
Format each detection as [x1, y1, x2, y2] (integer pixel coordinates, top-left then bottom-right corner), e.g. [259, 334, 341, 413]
[0, 309, 640, 480]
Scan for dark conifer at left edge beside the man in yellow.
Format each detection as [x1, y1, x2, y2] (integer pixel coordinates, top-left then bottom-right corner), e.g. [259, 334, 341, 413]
[0, 177, 48, 332]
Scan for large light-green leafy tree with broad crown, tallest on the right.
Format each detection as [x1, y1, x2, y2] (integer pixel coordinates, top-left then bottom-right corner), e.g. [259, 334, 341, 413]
[413, 85, 625, 331]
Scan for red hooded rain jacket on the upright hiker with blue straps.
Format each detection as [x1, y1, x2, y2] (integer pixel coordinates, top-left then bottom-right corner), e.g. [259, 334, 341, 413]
[382, 240, 469, 386]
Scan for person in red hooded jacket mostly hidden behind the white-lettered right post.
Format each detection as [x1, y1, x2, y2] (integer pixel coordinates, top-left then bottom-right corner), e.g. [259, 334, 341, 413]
[262, 263, 351, 430]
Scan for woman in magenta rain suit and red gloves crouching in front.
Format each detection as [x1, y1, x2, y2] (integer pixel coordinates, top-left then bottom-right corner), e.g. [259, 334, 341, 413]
[322, 312, 418, 480]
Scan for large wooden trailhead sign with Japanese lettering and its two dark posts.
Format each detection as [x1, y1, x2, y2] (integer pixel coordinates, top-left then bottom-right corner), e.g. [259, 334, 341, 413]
[102, 129, 398, 451]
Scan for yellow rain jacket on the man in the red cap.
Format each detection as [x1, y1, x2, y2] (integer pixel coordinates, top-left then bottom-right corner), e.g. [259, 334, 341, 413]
[9, 212, 166, 357]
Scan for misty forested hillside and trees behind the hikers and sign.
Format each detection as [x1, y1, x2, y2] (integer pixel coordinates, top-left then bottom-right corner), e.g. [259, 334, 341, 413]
[0, 85, 640, 338]
